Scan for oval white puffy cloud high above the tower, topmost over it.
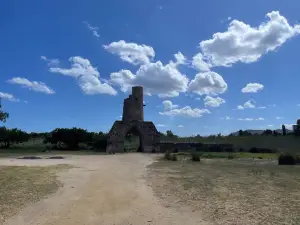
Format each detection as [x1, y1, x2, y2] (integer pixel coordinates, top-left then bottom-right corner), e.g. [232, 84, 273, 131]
[103, 40, 155, 65]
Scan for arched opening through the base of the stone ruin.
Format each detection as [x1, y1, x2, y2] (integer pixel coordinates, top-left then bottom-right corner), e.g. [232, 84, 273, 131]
[124, 126, 144, 152]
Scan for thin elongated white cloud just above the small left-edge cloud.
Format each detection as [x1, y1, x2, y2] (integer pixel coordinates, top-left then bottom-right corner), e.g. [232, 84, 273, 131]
[7, 77, 55, 94]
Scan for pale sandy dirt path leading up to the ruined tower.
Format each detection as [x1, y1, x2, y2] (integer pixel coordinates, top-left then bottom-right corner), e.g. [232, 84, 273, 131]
[0, 154, 206, 225]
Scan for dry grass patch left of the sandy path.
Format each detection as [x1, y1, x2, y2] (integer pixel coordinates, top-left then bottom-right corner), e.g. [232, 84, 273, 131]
[0, 165, 70, 224]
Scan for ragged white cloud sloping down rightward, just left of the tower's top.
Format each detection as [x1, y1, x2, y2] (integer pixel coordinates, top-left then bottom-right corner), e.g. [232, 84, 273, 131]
[49, 56, 117, 95]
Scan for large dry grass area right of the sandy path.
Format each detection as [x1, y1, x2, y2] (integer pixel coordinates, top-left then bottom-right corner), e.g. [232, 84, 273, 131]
[149, 159, 300, 225]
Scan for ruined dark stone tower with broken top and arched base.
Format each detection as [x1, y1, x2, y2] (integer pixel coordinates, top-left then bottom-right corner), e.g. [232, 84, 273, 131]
[106, 86, 159, 152]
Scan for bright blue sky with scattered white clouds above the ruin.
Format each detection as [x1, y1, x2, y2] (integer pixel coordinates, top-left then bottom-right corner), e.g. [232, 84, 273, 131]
[0, 0, 300, 135]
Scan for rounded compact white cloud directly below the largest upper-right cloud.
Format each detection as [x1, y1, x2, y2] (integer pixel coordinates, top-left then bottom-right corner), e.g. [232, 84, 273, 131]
[188, 71, 227, 95]
